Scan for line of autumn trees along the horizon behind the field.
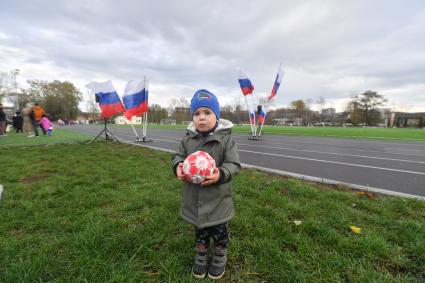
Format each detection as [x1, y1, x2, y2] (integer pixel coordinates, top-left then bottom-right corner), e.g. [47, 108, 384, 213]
[0, 76, 387, 126]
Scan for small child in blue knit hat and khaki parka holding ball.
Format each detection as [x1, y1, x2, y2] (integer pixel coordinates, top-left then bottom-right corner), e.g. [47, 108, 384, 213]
[173, 89, 241, 279]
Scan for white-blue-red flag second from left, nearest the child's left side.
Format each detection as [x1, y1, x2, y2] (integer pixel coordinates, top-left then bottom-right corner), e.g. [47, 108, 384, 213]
[123, 80, 149, 120]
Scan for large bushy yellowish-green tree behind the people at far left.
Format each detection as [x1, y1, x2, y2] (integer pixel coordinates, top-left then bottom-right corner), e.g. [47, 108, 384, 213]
[28, 80, 82, 120]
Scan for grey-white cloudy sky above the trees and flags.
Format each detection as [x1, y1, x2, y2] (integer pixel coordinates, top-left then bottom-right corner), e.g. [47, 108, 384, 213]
[0, 0, 425, 112]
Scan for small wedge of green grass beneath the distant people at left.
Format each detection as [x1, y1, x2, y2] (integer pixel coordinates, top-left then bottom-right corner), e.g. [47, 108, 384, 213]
[0, 128, 93, 147]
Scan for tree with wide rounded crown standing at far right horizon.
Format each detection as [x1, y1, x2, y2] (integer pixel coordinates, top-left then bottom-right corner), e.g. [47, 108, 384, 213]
[355, 90, 387, 126]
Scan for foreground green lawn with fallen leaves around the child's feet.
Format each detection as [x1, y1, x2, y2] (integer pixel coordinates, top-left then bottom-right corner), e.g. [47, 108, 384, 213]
[0, 142, 425, 282]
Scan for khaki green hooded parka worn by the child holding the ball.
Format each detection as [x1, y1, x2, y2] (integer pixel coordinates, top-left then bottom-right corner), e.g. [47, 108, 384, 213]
[173, 119, 241, 228]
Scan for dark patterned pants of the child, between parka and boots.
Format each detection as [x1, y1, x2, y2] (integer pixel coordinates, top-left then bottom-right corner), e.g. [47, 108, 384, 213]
[195, 222, 229, 249]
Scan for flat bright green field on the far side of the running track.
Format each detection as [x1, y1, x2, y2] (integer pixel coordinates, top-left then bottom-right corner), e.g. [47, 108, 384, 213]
[114, 125, 425, 141]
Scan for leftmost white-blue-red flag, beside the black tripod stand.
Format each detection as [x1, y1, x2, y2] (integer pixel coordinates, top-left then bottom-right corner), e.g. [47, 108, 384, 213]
[86, 80, 124, 118]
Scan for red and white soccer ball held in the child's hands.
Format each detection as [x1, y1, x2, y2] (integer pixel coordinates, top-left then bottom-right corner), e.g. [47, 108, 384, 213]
[183, 151, 215, 184]
